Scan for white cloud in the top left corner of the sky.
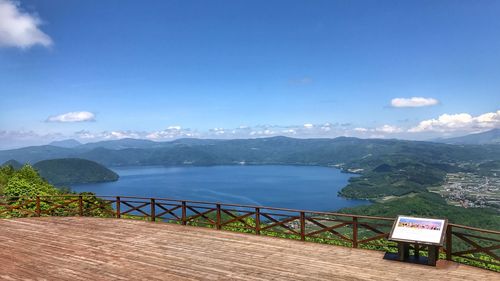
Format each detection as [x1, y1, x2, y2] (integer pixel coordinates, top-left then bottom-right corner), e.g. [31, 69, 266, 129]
[0, 0, 52, 48]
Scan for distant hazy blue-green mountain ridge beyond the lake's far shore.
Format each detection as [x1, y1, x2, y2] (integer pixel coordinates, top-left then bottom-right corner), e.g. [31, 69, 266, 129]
[0, 137, 500, 168]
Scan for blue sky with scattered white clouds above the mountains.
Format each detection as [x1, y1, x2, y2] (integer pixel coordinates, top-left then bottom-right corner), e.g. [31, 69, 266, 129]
[0, 0, 500, 149]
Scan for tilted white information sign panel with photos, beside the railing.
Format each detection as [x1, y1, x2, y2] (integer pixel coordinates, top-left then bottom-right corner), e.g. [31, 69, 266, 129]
[389, 216, 447, 246]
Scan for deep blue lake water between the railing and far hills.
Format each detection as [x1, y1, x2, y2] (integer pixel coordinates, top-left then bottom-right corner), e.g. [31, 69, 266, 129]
[72, 166, 369, 211]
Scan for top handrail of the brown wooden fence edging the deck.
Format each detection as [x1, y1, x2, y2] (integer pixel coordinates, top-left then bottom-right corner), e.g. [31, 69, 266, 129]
[0, 194, 500, 235]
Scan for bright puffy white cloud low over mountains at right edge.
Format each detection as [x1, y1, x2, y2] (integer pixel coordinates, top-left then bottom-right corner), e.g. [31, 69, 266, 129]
[408, 110, 500, 133]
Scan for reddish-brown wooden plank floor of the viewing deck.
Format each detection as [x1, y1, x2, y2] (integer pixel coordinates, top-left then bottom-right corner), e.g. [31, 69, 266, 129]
[0, 218, 500, 281]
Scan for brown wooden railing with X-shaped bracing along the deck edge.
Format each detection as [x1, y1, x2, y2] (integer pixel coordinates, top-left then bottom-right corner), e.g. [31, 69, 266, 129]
[0, 195, 500, 271]
